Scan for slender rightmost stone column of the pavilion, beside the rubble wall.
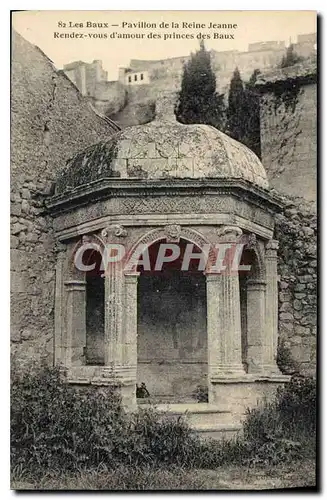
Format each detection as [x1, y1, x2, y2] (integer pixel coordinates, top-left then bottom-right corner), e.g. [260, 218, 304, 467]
[265, 240, 280, 373]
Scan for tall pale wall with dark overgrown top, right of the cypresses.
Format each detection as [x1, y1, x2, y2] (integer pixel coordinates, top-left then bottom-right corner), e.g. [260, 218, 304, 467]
[260, 66, 317, 201]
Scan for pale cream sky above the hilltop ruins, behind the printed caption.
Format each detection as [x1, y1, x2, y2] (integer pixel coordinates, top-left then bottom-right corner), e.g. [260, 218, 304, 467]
[12, 10, 316, 80]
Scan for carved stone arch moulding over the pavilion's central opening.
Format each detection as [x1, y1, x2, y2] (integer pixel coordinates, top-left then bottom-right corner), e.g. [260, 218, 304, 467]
[125, 224, 215, 274]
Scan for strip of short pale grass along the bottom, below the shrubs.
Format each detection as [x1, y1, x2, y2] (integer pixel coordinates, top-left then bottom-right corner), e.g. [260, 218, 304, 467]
[12, 459, 316, 491]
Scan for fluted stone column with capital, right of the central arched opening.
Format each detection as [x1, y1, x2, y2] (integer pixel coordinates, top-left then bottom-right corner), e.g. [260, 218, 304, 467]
[207, 227, 244, 381]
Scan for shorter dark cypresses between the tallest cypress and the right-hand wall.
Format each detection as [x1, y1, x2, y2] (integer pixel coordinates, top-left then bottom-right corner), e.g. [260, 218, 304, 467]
[226, 68, 261, 156]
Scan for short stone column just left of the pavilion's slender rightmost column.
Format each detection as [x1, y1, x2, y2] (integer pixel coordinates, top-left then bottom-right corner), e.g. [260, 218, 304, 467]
[247, 280, 269, 373]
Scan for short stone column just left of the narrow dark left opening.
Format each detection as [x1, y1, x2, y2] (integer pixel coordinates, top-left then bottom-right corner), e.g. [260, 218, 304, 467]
[62, 280, 86, 368]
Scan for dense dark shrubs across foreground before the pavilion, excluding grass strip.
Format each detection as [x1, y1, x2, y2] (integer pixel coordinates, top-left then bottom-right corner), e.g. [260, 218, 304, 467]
[11, 368, 316, 482]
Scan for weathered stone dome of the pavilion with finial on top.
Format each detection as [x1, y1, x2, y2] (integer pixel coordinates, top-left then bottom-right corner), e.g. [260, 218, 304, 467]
[56, 93, 268, 193]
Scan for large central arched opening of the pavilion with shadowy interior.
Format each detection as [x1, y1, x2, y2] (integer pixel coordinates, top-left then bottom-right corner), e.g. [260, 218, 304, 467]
[137, 239, 208, 402]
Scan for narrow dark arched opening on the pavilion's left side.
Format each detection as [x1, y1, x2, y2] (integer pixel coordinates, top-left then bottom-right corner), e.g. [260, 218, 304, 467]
[83, 249, 104, 365]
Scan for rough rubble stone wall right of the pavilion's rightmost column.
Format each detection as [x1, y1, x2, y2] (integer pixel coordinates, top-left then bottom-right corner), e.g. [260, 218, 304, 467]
[276, 193, 317, 373]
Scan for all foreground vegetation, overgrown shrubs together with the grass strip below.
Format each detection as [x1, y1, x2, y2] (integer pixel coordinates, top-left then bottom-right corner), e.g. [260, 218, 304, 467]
[11, 368, 316, 490]
